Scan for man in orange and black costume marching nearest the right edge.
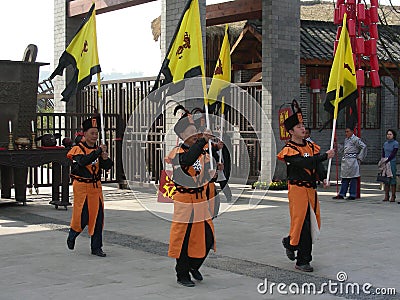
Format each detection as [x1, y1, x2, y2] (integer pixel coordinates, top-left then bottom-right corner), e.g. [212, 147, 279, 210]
[277, 100, 334, 272]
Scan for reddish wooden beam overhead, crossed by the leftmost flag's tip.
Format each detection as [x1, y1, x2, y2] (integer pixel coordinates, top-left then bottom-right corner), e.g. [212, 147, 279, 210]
[68, 0, 156, 17]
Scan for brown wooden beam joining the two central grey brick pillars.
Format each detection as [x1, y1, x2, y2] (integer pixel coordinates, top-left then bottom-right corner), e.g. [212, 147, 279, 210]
[206, 0, 262, 26]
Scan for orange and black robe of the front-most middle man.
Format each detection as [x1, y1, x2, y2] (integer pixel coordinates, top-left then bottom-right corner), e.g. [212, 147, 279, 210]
[165, 139, 215, 258]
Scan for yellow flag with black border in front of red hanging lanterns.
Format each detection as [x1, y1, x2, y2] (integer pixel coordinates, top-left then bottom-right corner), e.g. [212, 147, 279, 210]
[324, 14, 358, 119]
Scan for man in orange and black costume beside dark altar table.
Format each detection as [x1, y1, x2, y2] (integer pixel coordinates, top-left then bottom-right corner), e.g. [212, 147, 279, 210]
[67, 117, 113, 257]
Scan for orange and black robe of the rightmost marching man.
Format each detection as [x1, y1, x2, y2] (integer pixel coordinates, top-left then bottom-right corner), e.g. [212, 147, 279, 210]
[277, 140, 328, 246]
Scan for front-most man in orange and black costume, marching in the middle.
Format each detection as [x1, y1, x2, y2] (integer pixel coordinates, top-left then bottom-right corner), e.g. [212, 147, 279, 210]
[166, 106, 215, 287]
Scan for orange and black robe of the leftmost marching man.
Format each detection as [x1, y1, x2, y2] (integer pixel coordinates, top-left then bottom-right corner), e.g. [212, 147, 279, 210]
[67, 142, 113, 235]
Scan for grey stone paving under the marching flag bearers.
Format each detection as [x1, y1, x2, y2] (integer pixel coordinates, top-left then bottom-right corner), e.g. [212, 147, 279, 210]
[0, 175, 400, 300]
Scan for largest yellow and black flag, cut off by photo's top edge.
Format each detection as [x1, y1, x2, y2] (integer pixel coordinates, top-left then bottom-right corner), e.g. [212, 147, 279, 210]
[150, 0, 204, 101]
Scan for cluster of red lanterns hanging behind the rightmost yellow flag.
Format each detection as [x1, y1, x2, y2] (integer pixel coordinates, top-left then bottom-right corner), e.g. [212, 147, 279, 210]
[333, 0, 381, 87]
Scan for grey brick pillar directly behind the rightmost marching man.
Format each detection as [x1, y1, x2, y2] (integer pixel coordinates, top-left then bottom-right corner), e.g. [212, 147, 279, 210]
[261, 0, 300, 181]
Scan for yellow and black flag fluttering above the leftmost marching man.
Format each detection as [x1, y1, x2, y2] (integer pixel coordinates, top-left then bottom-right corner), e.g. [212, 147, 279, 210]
[49, 3, 101, 102]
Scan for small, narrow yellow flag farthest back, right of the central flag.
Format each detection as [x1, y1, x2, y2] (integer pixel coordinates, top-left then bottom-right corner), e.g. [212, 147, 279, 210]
[207, 25, 231, 114]
